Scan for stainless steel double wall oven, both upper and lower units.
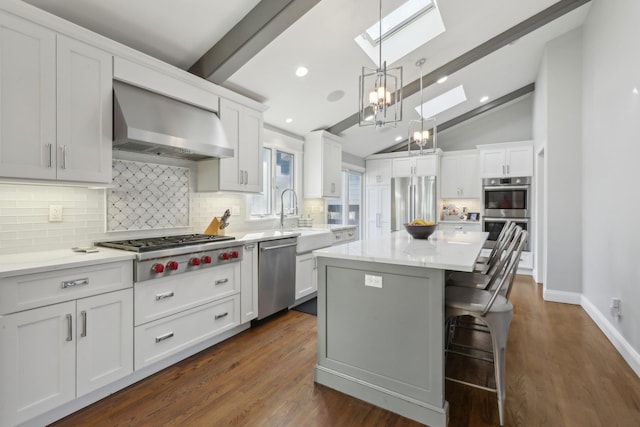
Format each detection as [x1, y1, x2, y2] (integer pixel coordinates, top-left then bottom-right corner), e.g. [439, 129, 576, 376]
[482, 176, 531, 251]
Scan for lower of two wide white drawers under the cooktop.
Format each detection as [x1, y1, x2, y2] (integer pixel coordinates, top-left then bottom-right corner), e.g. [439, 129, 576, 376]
[134, 295, 240, 370]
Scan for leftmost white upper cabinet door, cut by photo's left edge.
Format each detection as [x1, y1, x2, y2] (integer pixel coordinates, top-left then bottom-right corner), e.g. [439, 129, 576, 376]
[0, 13, 56, 179]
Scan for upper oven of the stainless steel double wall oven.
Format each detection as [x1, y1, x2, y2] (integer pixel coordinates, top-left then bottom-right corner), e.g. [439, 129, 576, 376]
[482, 176, 531, 218]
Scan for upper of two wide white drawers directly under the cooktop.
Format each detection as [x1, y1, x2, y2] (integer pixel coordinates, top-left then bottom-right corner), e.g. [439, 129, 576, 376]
[134, 262, 240, 326]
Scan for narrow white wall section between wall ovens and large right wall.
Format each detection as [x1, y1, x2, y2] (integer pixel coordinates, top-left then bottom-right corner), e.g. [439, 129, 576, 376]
[538, 29, 582, 304]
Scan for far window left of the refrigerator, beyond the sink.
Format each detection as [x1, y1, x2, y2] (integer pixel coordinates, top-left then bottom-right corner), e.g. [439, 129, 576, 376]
[327, 170, 362, 237]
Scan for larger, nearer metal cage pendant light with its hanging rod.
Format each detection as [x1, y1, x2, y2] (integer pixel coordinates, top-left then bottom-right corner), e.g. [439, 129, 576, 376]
[358, 0, 402, 128]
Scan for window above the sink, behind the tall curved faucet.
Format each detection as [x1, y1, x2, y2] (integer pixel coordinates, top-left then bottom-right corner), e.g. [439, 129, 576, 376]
[250, 147, 301, 217]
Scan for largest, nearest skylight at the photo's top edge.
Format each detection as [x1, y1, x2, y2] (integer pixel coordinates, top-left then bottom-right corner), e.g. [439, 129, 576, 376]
[354, 0, 445, 66]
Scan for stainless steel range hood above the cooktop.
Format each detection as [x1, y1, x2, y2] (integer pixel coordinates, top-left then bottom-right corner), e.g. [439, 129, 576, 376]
[113, 81, 233, 160]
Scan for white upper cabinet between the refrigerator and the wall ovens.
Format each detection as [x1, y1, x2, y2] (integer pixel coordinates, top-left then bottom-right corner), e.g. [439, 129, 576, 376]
[440, 151, 481, 199]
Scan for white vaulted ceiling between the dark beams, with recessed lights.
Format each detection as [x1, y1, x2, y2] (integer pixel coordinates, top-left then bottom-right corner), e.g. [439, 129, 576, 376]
[24, 0, 590, 157]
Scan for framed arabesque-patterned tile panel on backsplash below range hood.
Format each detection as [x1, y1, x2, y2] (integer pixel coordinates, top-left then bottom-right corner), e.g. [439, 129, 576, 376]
[107, 159, 189, 231]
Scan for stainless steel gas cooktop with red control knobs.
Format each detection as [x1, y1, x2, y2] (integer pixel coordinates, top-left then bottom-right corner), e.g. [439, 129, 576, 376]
[96, 234, 243, 282]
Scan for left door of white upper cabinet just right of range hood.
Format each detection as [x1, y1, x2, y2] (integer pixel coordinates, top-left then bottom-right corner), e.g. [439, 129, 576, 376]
[218, 99, 243, 191]
